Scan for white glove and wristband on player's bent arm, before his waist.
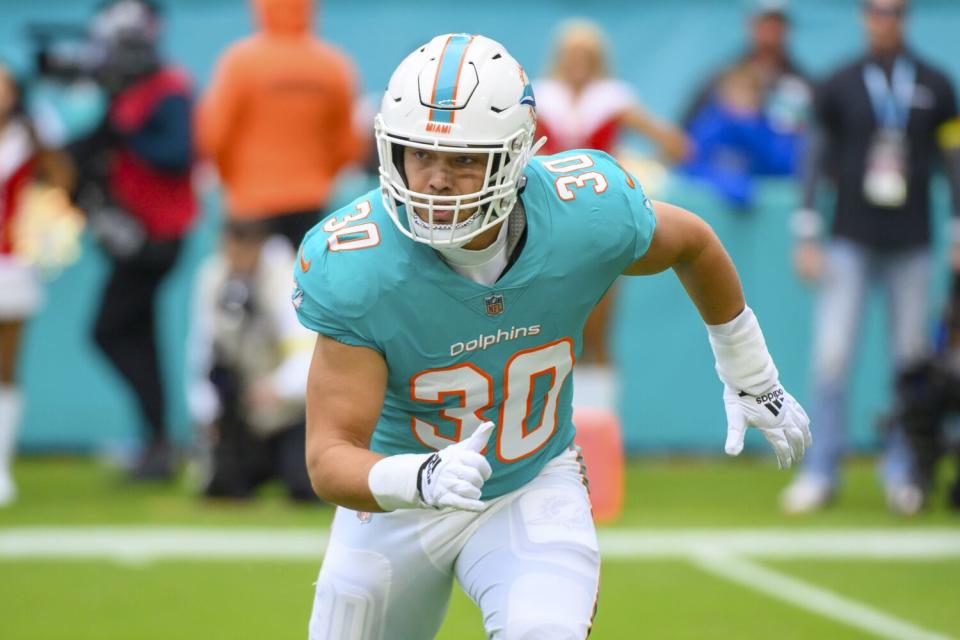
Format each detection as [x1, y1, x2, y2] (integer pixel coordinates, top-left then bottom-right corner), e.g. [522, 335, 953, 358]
[367, 422, 496, 511]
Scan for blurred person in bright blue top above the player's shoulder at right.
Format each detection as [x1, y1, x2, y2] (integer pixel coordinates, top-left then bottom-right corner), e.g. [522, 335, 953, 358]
[682, 64, 801, 208]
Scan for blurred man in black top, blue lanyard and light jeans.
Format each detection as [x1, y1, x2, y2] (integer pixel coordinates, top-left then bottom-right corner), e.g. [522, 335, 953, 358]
[782, 0, 960, 514]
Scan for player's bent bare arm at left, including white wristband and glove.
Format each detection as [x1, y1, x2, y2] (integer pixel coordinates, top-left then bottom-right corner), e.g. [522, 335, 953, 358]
[307, 335, 493, 511]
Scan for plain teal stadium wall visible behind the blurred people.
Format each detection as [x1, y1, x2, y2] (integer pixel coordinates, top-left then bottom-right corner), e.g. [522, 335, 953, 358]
[0, 0, 960, 452]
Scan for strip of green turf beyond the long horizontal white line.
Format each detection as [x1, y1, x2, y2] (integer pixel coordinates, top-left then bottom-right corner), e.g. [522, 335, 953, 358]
[7, 457, 960, 528]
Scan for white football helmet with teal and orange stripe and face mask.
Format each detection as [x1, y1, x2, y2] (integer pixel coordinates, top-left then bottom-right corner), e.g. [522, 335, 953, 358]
[374, 34, 539, 249]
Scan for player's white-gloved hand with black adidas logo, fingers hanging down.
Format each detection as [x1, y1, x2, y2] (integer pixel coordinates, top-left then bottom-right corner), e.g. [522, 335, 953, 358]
[723, 383, 813, 469]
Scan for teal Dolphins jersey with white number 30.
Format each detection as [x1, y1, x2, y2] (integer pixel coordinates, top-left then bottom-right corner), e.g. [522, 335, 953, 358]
[294, 150, 656, 498]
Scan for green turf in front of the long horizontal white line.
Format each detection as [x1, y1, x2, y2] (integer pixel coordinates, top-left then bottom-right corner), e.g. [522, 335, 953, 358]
[0, 561, 960, 640]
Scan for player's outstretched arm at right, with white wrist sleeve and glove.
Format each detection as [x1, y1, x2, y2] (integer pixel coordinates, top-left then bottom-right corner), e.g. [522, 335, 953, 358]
[624, 202, 812, 467]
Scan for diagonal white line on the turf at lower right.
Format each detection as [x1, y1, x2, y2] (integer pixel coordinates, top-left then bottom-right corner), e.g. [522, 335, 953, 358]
[693, 553, 950, 640]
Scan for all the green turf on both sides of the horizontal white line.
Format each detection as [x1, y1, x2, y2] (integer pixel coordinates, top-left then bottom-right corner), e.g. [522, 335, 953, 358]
[0, 458, 960, 640]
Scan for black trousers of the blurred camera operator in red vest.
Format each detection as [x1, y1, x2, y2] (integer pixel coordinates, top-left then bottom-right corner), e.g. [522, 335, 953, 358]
[94, 240, 181, 444]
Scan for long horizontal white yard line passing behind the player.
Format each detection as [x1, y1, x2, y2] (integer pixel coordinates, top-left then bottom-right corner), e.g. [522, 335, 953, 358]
[0, 526, 960, 560]
